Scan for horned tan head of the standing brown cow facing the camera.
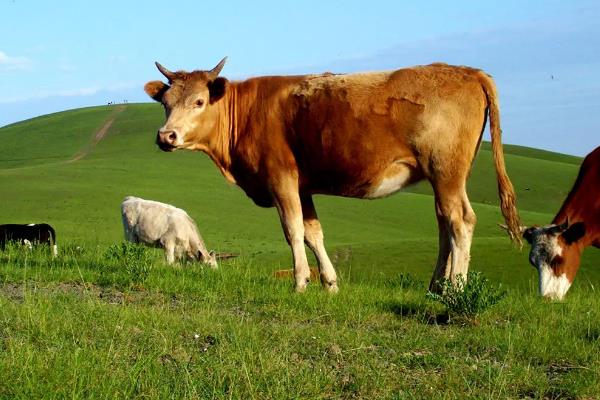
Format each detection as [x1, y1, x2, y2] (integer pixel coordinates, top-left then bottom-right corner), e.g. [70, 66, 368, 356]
[144, 57, 227, 151]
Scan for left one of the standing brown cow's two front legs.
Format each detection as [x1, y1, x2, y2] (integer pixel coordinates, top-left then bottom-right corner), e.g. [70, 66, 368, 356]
[273, 182, 310, 292]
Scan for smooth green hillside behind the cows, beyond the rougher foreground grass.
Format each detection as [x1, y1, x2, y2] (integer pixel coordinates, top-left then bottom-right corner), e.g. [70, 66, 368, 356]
[0, 104, 600, 286]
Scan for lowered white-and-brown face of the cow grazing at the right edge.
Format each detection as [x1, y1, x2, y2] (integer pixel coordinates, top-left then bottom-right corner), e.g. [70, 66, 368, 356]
[523, 222, 585, 300]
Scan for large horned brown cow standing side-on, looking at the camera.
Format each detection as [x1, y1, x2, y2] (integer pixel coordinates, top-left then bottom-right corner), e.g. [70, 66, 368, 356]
[144, 59, 521, 292]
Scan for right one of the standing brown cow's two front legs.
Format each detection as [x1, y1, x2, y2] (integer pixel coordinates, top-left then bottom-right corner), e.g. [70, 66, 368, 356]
[301, 196, 338, 293]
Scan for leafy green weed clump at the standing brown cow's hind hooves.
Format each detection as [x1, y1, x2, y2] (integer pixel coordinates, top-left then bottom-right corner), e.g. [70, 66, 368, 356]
[427, 272, 507, 318]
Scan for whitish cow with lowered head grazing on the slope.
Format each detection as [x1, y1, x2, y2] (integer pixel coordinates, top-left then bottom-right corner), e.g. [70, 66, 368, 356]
[121, 196, 217, 268]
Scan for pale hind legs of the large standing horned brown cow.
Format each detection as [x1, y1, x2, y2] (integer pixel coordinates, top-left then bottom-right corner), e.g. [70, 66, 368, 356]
[430, 186, 477, 292]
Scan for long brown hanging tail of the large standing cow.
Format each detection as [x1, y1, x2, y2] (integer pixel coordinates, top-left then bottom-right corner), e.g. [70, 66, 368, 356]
[480, 72, 523, 246]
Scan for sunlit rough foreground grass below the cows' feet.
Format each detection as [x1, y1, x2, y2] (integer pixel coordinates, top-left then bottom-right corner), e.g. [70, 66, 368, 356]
[0, 247, 600, 399]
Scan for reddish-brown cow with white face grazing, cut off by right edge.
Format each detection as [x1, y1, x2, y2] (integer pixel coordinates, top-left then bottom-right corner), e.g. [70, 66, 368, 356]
[523, 147, 600, 300]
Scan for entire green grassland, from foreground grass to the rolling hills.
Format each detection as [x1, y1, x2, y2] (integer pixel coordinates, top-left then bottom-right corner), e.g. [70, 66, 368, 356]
[0, 104, 600, 399]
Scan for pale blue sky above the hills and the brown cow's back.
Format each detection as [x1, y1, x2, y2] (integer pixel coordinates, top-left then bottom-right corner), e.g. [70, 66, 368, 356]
[0, 0, 600, 155]
